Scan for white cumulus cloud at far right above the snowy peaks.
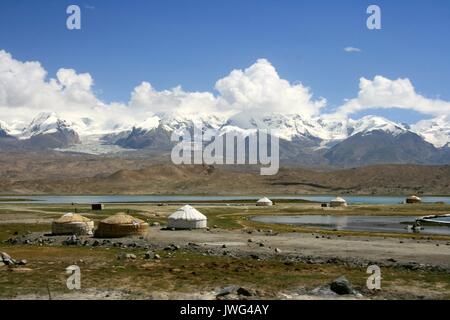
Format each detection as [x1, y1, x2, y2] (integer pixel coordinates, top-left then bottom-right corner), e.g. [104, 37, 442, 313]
[337, 76, 450, 115]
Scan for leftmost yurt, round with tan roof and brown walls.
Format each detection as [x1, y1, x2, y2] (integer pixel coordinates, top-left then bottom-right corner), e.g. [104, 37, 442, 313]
[52, 212, 94, 236]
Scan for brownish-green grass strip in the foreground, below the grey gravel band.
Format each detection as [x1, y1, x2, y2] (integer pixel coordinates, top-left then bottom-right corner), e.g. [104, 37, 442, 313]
[0, 246, 450, 299]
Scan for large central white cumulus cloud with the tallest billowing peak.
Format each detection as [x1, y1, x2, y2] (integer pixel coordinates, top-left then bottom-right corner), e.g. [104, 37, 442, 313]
[129, 59, 326, 117]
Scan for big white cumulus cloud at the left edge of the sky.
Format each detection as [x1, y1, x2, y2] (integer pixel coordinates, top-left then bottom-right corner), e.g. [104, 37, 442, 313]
[0, 50, 134, 131]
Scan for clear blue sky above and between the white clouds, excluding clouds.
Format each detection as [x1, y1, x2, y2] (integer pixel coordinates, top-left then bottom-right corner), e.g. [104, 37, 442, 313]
[0, 0, 450, 122]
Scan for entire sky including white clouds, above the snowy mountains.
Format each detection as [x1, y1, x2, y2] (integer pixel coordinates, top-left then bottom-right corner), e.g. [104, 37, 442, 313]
[0, 0, 450, 127]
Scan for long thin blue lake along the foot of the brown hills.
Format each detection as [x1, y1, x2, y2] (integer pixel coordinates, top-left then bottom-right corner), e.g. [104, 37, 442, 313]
[0, 195, 450, 204]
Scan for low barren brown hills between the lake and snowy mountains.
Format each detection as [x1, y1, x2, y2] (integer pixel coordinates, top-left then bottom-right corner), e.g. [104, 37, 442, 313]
[0, 157, 450, 195]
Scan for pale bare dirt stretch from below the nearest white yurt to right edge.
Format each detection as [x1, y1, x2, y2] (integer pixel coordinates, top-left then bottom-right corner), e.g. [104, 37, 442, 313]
[147, 228, 450, 269]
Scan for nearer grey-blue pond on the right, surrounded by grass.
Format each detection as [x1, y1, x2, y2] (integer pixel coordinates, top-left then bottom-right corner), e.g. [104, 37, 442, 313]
[252, 215, 450, 235]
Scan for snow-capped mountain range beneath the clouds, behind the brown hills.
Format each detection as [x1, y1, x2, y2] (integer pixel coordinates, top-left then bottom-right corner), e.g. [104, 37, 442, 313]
[0, 112, 450, 167]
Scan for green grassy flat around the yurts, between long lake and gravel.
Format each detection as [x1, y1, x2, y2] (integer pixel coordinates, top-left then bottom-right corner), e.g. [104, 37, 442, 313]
[0, 203, 450, 240]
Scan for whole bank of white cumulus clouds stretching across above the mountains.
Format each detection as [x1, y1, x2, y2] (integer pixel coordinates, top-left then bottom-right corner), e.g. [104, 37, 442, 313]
[0, 50, 450, 133]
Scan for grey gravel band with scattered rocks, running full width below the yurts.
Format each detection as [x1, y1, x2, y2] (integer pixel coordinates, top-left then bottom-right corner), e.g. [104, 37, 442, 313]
[6, 227, 450, 273]
